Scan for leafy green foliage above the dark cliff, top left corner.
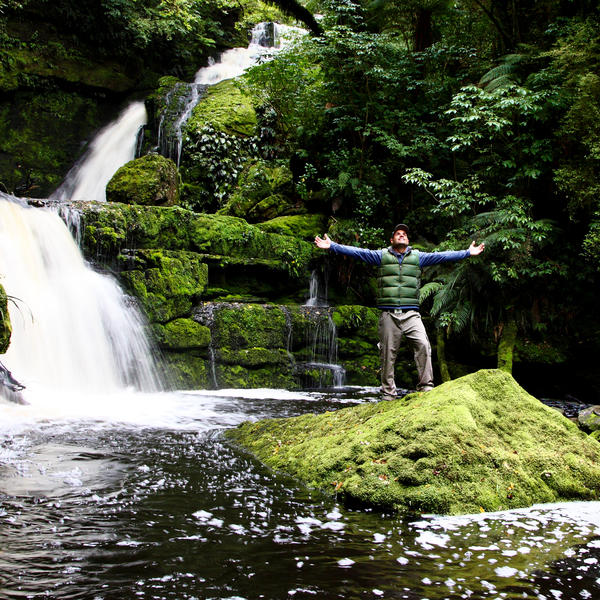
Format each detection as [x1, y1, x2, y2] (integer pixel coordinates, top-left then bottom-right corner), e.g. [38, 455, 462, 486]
[3, 0, 239, 73]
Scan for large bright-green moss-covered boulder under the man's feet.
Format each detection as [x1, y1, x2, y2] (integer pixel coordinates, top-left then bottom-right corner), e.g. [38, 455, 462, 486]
[227, 370, 600, 514]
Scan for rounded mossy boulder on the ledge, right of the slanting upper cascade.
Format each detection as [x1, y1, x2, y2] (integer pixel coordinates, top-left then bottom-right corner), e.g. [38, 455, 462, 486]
[106, 154, 180, 206]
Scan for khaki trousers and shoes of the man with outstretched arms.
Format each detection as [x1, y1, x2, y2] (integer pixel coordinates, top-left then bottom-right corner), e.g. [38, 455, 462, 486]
[379, 310, 433, 400]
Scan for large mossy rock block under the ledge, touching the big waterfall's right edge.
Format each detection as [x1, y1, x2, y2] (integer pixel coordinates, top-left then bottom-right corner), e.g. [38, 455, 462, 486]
[120, 250, 208, 323]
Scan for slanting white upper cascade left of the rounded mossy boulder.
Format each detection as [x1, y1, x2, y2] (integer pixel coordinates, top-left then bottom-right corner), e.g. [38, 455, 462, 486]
[50, 102, 148, 202]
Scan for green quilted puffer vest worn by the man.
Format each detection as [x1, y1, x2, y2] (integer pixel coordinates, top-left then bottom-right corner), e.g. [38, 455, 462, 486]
[377, 249, 421, 307]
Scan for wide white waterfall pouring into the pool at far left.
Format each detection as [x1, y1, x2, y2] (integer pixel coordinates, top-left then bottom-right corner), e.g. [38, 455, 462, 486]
[0, 194, 160, 400]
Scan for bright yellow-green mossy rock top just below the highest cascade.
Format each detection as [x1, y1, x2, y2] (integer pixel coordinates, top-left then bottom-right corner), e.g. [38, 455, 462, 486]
[185, 79, 256, 137]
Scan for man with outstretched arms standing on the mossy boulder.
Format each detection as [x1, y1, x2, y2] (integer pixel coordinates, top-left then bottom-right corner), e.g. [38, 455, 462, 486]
[315, 223, 485, 400]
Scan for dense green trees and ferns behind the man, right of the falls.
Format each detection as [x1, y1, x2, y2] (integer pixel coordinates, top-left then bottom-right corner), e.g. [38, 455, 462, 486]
[238, 0, 600, 396]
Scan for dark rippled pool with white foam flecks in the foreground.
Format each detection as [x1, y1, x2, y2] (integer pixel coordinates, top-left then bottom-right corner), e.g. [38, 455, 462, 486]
[0, 390, 600, 600]
